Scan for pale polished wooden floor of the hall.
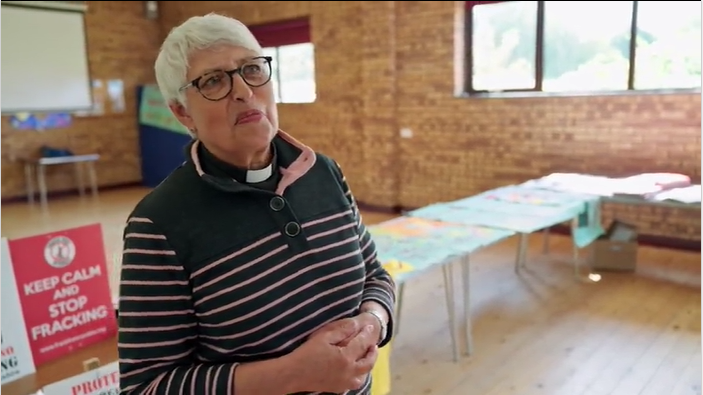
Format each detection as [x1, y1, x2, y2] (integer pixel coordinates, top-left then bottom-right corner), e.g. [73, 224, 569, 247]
[2, 189, 703, 395]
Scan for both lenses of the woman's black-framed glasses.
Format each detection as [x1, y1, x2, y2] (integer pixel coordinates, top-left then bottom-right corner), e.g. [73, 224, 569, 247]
[198, 59, 271, 100]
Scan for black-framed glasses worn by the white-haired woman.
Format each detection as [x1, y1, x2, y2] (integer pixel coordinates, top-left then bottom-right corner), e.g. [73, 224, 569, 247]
[180, 56, 273, 101]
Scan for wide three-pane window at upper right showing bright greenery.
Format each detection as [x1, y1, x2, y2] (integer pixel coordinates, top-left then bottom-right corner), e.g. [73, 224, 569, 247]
[465, 1, 701, 93]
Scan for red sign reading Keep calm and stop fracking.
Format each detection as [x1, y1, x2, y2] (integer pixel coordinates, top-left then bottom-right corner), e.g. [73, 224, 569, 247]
[9, 224, 117, 366]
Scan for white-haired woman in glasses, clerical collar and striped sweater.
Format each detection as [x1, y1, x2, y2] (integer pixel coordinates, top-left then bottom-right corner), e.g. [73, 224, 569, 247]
[118, 14, 395, 395]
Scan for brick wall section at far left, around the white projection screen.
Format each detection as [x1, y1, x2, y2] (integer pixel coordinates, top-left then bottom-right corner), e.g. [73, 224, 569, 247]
[2, 1, 161, 199]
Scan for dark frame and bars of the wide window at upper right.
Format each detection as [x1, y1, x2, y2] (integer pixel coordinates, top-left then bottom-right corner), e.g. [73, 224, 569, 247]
[461, 0, 701, 98]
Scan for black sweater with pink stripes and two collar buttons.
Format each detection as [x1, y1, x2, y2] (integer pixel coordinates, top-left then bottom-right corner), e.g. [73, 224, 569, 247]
[118, 132, 395, 395]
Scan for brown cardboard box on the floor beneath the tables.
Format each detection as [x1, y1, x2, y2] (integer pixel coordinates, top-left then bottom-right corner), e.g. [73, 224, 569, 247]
[591, 220, 638, 272]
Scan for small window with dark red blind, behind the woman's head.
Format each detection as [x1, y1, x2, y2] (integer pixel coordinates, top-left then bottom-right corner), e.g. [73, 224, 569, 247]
[250, 18, 316, 103]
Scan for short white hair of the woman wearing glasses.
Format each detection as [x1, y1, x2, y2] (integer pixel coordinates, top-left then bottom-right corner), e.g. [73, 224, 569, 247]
[154, 13, 262, 105]
